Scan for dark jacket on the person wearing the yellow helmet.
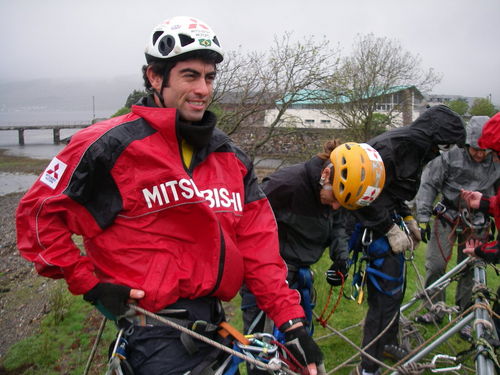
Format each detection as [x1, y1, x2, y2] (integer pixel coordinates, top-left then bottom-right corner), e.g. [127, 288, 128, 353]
[261, 156, 348, 267]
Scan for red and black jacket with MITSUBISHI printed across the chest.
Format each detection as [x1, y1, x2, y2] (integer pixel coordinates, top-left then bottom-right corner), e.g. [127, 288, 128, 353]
[17, 99, 304, 326]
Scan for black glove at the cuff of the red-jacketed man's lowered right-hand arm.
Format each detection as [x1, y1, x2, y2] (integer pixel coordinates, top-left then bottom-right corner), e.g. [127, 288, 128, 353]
[285, 326, 323, 366]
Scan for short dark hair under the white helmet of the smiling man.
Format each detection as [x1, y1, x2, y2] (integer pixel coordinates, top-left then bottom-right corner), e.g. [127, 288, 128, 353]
[142, 50, 220, 93]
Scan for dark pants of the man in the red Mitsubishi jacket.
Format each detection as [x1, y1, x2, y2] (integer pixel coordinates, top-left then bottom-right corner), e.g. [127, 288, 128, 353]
[126, 298, 228, 375]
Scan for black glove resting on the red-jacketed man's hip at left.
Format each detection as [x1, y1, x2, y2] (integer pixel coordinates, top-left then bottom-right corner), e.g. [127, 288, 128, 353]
[83, 283, 131, 320]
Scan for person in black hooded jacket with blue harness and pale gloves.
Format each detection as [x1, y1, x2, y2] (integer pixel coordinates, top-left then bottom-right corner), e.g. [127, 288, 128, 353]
[352, 105, 465, 375]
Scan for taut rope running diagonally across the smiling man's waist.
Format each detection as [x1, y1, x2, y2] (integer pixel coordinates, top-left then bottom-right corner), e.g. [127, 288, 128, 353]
[129, 304, 297, 375]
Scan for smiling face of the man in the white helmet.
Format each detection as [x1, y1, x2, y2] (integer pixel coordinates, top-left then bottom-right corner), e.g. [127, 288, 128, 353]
[162, 60, 215, 122]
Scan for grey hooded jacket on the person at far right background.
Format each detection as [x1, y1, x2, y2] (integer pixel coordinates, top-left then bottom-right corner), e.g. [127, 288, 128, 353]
[415, 116, 500, 223]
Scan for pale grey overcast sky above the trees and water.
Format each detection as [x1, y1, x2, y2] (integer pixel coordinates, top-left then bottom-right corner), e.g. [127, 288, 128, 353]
[0, 0, 500, 103]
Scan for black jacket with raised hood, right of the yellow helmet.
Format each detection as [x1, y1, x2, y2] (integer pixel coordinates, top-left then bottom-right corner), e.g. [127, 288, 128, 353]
[353, 105, 465, 237]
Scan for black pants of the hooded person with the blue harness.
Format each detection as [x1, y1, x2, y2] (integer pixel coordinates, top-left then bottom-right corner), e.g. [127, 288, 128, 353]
[361, 253, 404, 372]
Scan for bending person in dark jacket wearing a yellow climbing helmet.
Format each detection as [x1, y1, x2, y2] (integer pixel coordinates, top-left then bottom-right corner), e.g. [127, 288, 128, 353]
[241, 140, 384, 374]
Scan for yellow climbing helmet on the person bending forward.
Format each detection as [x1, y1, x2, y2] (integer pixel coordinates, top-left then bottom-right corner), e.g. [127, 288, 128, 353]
[330, 142, 385, 210]
